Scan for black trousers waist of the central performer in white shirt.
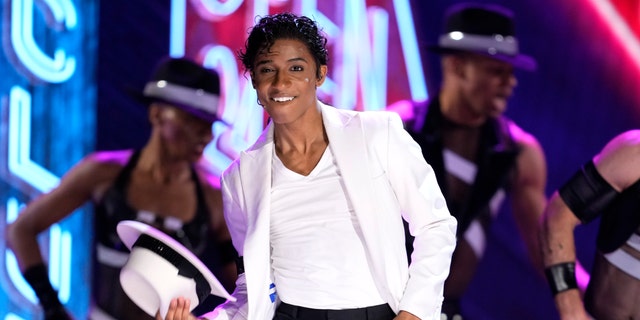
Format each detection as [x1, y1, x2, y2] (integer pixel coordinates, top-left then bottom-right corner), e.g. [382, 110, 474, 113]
[273, 302, 396, 320]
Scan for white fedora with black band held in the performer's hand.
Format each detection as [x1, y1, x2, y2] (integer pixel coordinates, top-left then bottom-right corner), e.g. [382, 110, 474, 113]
[117, 220, 236, 318]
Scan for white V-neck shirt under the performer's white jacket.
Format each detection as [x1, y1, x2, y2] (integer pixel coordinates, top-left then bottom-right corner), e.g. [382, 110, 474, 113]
[270, 148, 384, 309]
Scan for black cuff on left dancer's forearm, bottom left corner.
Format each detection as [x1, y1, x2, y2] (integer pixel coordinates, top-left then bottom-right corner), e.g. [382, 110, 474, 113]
[22, 264, 72, 320]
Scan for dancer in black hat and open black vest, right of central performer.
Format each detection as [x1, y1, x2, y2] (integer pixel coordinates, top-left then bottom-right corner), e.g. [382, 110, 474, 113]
[400, 3, 547, 320]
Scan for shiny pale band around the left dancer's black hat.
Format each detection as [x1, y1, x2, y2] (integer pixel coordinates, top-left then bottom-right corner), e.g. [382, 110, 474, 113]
[143, 80, 220, 115]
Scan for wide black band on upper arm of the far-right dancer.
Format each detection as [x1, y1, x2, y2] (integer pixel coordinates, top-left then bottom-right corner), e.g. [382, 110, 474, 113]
[558, 161, 618, 223]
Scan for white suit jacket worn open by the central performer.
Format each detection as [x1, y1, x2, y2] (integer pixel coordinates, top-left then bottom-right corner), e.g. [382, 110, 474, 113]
[206, 102, 456, 320]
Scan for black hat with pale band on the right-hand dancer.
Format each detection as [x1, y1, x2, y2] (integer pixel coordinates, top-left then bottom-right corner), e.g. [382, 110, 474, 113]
[430, 3, 536, 70]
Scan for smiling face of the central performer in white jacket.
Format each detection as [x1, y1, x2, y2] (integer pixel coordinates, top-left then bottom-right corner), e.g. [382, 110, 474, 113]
[251, 39, 327, 124]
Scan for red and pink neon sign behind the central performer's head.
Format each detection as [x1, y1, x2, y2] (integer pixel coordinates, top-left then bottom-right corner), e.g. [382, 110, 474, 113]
[170, 0, 428, 173]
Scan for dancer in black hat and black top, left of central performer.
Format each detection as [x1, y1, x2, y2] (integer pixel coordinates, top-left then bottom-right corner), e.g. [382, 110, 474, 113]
[7, 58, 236, 319]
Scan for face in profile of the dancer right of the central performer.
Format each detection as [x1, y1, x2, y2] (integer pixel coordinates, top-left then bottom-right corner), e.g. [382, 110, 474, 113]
[460, 54, 517, 117]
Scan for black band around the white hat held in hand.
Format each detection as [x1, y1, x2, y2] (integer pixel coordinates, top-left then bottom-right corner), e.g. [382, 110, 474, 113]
[131, 234, 211, 303]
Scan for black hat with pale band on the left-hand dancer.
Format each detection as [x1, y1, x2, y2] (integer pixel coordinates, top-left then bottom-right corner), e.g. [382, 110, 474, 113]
[138, 58, 220, 122]
